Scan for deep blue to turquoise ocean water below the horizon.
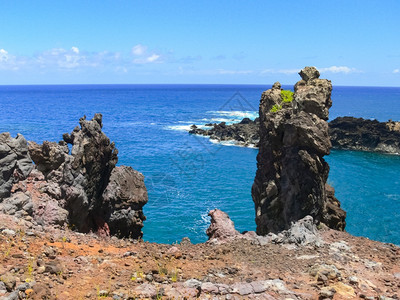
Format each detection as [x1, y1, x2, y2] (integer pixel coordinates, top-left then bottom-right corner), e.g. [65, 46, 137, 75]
[0, 85, 400, 244]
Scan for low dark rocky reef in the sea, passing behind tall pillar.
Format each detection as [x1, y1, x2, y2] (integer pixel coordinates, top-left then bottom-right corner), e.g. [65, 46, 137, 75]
[189, 117, 400, 154]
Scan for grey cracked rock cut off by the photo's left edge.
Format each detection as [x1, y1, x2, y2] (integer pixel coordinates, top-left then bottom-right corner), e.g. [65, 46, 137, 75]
[0, 132, 33, 202]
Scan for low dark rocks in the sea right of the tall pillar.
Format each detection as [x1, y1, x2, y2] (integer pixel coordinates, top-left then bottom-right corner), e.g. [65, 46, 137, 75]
[329, 117, 400, 154]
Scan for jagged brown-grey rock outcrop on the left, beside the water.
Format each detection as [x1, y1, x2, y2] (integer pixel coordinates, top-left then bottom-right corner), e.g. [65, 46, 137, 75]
[0, 114, 148, 238]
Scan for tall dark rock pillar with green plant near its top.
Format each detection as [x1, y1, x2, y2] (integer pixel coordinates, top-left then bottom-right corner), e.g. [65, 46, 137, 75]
[252, 67, 346, 235]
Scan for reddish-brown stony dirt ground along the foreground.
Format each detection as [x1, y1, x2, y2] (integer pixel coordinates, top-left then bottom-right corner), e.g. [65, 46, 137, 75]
[0, 215, 400, 299]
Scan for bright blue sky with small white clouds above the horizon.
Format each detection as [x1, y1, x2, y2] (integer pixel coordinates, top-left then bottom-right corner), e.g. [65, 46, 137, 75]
[0, 0, 400, 86]
